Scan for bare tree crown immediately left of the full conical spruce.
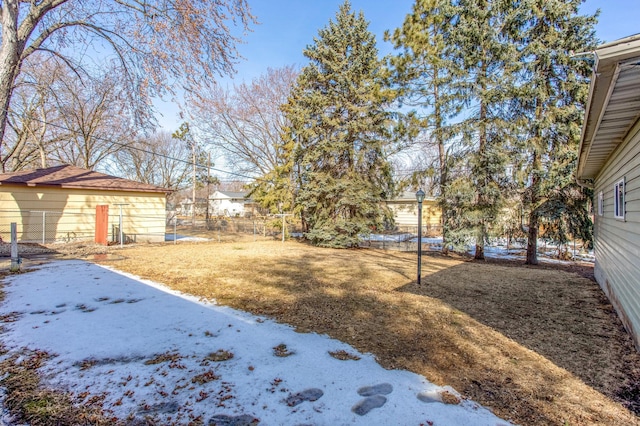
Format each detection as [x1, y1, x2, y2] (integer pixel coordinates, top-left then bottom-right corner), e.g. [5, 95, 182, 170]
[192, 66, 298, 175]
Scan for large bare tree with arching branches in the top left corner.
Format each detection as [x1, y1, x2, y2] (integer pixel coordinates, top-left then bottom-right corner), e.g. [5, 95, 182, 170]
[0, 0, 254, 163]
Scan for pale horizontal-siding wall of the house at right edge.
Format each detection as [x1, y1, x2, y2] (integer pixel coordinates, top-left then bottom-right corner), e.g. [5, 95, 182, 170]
[594, 121, 640, 348]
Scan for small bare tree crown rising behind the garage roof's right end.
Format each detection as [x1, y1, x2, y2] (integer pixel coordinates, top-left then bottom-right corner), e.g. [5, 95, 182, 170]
[111, 131, 191, 190]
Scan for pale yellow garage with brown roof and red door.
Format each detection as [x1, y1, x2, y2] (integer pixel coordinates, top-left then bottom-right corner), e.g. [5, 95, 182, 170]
[0, 165, 170, 242]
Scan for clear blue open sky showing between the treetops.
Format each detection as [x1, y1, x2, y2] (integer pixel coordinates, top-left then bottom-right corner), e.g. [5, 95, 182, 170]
[158, 0, 640, 165]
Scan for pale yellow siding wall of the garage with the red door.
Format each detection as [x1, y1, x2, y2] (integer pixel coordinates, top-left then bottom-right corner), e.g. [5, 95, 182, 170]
[0, 185, 166, 242]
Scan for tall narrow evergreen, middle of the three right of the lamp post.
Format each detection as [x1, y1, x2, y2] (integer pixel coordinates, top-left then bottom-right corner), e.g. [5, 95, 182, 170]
[448, 0, 518, 259]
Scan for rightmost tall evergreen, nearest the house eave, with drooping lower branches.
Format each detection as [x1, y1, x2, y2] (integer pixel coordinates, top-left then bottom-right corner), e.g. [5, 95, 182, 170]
[514, 0, 596, 264]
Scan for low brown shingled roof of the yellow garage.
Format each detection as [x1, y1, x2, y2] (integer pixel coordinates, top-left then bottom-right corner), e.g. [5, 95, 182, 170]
[0, 164, 171, 193]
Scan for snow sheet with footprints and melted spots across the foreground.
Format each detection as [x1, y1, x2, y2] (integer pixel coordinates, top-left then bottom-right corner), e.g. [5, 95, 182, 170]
[0, 260, 508, 425]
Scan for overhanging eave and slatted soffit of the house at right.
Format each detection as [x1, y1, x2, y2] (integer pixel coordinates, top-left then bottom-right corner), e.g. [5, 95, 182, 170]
[577, 34, 640, 180]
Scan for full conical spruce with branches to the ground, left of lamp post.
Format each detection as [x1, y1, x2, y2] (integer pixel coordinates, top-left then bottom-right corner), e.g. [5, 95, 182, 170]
[284, 1, 392, 247]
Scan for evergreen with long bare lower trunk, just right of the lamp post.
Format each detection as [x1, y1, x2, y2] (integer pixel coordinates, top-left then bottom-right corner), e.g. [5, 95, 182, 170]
[386, 0, 461, 253]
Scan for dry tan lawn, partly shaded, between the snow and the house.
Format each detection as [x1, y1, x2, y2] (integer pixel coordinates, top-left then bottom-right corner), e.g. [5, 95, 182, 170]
[82, 241, 640, 425]
